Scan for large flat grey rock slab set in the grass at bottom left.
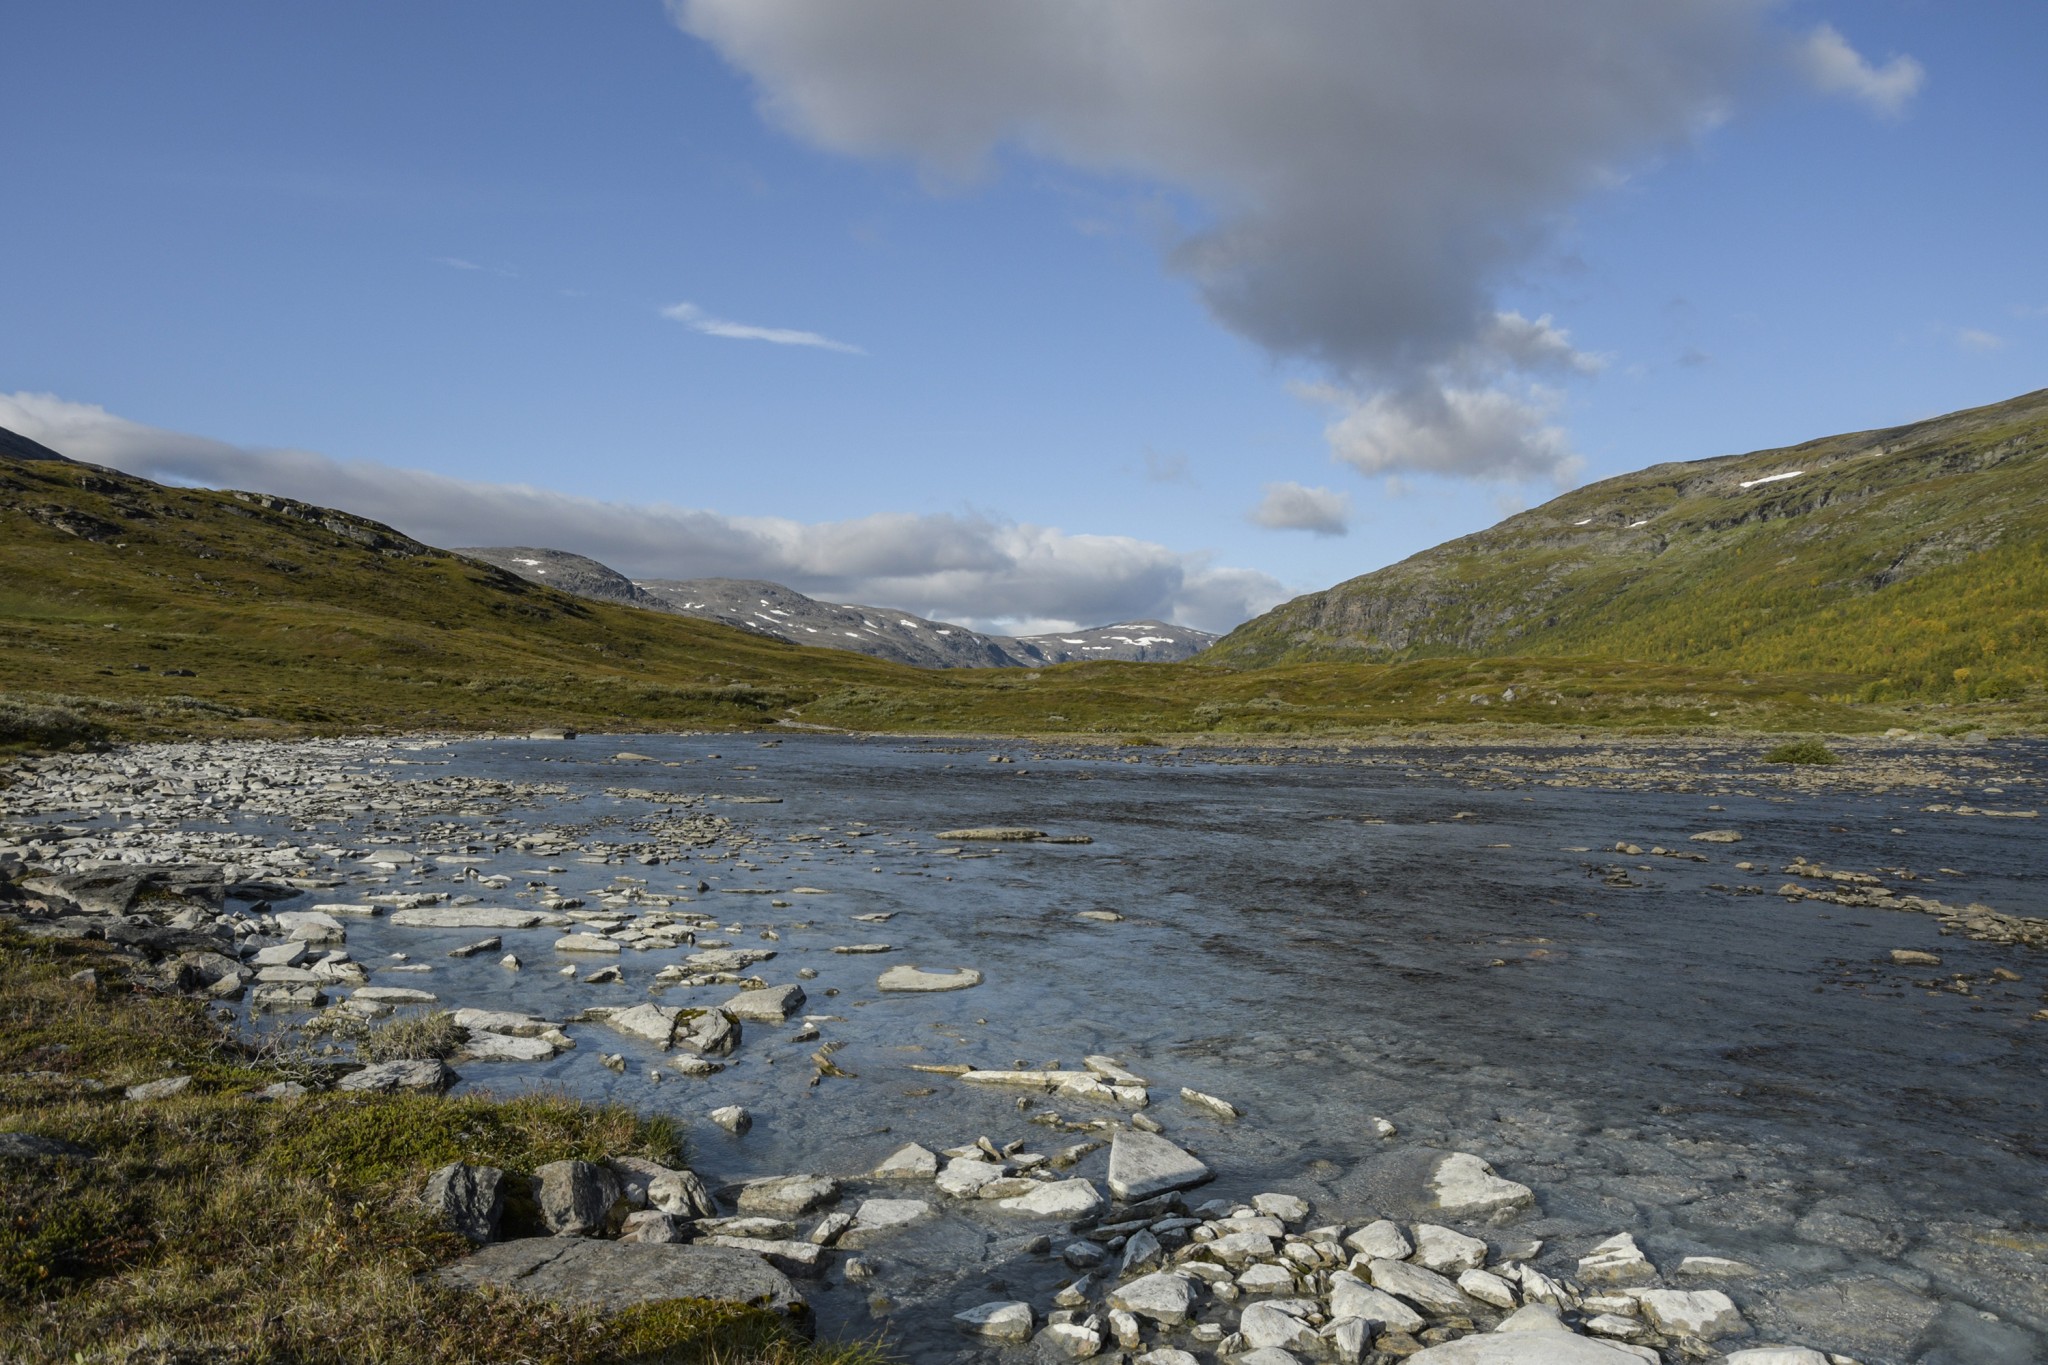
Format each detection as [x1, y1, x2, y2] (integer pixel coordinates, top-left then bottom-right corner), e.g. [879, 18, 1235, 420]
[438, 1236, 809, 1324]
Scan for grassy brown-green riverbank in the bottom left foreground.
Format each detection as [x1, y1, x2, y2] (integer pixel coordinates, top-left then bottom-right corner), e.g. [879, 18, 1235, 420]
[0, 925, 879, 1365]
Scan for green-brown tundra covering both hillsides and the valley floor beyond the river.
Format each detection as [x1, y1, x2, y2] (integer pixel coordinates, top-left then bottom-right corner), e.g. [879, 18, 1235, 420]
[0, 399, 2048, 747]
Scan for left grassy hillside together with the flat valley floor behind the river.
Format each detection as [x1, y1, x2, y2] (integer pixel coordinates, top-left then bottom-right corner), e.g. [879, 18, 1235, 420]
[0, 442, 1982, 745]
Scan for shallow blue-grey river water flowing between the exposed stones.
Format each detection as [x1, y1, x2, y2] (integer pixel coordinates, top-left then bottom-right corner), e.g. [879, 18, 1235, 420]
[16, 735, 2048, 1363]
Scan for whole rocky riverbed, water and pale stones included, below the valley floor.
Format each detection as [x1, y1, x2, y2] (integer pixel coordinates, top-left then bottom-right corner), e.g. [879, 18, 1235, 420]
[0, 735, 2048, 1365]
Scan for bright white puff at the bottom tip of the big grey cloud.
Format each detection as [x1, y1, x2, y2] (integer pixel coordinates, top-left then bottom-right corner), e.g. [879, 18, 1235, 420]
[1300, 383, 1583, 487]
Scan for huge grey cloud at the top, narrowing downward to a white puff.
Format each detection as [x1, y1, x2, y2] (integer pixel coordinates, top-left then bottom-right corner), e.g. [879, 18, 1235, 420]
[670, 0, 1919, 479]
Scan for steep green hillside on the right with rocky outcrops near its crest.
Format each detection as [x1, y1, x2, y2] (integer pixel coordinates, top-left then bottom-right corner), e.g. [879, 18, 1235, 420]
[1206, 391, 2048, 700]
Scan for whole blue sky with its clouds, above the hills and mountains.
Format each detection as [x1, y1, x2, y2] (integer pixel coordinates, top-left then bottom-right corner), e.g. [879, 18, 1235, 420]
[0, 0, 2048, 628]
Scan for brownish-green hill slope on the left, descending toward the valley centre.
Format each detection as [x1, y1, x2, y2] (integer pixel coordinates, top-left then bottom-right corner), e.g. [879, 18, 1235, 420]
[0, 444, 929, 733]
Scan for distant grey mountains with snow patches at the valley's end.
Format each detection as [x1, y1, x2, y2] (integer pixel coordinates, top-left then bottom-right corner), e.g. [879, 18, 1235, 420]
[457, 546, 1217, 669]
